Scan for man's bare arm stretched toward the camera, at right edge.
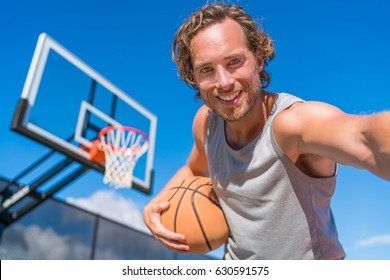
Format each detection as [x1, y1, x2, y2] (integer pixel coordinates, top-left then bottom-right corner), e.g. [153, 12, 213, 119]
[273, 102, 390, 180]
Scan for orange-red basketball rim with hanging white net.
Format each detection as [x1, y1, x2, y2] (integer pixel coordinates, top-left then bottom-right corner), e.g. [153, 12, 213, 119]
[95, 126, 149, 188]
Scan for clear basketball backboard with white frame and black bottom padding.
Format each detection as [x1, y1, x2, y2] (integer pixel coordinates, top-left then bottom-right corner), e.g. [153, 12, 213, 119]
[11, 33, 157, 193]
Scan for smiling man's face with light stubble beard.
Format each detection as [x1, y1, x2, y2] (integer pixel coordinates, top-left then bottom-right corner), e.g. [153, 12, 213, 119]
[191, 18, 263, 122]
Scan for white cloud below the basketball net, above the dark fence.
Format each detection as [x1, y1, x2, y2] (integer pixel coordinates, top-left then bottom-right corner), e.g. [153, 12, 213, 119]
[66, 190, 149, 232]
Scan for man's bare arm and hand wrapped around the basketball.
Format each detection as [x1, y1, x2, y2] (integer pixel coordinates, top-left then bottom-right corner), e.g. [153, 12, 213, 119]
[143, 106, 209, 253]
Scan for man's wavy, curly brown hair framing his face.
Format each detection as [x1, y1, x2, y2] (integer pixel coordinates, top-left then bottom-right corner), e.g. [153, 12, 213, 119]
[172, 3, 275, 97]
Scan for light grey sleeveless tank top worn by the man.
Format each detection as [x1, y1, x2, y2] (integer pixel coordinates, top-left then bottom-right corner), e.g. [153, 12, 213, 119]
[205, 93, 345, 260]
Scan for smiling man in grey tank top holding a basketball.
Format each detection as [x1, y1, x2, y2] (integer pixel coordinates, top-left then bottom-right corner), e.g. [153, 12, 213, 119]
[144, 4, 390, 259]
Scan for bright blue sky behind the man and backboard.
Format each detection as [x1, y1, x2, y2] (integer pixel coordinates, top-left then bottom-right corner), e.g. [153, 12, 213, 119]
[0, 0, 390, 259]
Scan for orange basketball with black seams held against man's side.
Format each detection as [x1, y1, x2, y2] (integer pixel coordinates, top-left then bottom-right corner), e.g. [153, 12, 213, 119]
[161, 176, 229, 254]
